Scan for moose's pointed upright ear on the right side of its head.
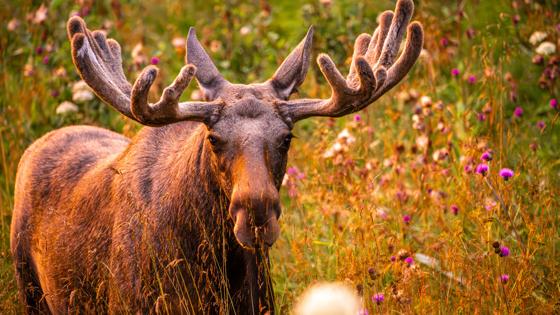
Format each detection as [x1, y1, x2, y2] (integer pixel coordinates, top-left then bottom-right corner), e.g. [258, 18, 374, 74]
[270, 26, 313, 99]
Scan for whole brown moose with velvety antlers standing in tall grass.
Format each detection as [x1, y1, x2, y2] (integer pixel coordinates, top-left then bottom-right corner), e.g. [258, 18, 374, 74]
[10, 0, 423, 314]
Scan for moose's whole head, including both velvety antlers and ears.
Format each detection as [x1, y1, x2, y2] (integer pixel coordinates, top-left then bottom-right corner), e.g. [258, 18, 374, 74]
[68, 0, 423, 252]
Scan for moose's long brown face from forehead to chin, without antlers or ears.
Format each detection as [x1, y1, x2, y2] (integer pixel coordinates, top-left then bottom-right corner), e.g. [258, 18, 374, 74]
[206, 85, 292, 248]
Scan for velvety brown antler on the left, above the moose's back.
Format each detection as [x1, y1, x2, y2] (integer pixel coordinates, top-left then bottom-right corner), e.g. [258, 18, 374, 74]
[68, 16, 223, 126]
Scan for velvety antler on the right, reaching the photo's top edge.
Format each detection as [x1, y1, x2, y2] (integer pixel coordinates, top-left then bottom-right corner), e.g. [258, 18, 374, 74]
[279, 0, 424, 122]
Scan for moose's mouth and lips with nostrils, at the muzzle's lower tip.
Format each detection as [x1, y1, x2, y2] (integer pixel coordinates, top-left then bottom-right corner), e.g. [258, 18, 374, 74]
[233, 208, 280, 250]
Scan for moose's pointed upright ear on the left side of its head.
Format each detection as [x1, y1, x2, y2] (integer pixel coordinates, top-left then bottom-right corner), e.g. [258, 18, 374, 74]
[185, 27, 227, 101]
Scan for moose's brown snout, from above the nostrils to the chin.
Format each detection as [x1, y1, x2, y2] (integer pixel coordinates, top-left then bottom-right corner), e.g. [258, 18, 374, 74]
[230, 193, 280, 249]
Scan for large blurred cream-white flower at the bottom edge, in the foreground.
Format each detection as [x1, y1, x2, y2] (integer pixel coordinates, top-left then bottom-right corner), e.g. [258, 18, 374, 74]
[294, 283, 361, 315]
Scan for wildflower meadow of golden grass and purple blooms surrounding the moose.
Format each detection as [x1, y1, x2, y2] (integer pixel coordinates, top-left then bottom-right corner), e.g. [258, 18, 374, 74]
[0, 0, 560, 314]
